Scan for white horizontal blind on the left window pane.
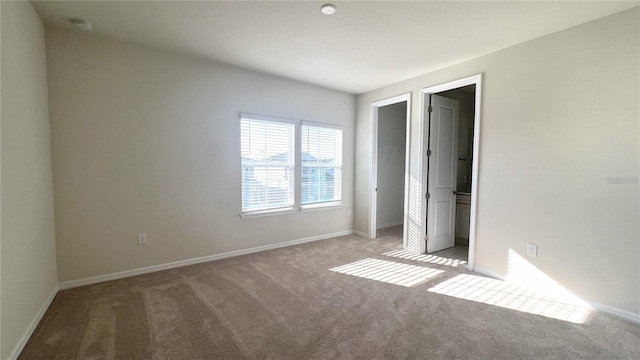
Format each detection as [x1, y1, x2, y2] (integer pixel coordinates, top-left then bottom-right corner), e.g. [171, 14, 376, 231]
[240, 114, 295, 213]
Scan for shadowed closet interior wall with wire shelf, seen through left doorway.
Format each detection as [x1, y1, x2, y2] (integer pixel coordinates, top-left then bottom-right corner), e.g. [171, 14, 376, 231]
[376, 102, 407, 228]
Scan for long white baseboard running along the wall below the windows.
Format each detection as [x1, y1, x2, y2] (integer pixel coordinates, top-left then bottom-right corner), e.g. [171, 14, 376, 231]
[58, 230, 353, 290]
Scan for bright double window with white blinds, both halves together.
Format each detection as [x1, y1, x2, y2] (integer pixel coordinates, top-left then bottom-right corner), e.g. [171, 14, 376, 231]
[240, 114, 342, 217]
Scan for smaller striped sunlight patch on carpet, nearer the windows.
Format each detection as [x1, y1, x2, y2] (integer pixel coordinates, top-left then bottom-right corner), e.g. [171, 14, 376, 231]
[329, 258, 444, 287]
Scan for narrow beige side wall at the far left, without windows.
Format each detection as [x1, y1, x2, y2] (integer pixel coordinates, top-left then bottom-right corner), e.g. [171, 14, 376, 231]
[0, 1, 57, 359]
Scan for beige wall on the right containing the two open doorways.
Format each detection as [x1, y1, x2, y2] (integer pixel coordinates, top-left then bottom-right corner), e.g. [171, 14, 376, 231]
[354, 8, 640, 314]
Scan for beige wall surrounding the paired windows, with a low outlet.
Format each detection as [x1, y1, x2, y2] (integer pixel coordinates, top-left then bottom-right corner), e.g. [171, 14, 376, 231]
[47, 28, 355, 282]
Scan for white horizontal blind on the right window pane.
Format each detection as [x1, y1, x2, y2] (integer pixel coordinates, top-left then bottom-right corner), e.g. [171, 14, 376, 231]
[301, 123, 342, 205]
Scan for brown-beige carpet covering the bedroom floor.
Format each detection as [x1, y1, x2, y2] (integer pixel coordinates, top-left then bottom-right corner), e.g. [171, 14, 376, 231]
[20, 229, 640, 360]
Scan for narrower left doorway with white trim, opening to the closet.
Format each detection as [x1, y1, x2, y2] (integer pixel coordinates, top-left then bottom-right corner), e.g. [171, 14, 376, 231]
[369, 94, 411, 239]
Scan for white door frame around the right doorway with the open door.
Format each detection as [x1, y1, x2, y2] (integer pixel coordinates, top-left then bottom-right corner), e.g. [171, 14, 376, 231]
[420, 74, 482, 271]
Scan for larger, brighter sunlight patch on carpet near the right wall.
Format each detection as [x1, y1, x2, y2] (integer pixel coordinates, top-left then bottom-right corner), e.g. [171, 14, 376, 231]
[428, 274, 593, 324]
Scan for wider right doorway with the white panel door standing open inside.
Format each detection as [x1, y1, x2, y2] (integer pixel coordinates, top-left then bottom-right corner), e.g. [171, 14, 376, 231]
[420, 75, 482, 270]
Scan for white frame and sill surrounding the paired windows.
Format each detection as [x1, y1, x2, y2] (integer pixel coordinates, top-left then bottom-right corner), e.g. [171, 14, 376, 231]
[238, 113, 344, 219]
